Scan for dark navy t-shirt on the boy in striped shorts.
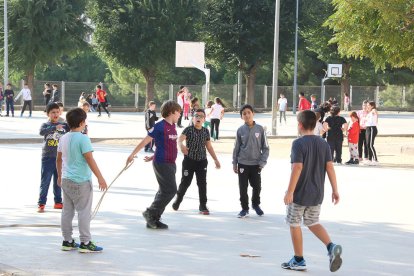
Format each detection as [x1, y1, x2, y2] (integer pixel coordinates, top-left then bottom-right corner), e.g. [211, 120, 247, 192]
[290, 135, 332, 206]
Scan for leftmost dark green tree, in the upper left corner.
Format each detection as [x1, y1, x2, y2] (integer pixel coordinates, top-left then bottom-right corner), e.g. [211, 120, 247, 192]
[1, 0, 89, 99]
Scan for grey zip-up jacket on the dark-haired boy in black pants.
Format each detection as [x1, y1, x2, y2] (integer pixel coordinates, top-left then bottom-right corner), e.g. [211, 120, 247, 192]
[233, 123, 269, 168]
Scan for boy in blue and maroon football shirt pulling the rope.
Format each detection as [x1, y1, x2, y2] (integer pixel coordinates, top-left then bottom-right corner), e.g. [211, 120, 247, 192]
[126, 100, 181, 229]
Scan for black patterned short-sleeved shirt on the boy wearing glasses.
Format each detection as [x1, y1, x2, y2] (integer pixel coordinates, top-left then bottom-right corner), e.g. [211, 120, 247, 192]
[182, 126, 210, 161]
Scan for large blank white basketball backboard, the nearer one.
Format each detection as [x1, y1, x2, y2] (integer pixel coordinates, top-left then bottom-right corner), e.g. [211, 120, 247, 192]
[175, 41, 205, 69]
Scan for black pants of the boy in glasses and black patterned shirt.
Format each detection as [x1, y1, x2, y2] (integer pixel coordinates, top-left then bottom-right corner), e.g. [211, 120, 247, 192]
[177, 156, 208, 205]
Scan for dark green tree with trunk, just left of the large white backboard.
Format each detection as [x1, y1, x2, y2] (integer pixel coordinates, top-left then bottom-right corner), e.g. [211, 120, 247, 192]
[88, 0, 201, 104]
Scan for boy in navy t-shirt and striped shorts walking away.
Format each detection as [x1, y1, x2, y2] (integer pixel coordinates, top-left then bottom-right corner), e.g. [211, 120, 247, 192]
[282, 111, 342, 272]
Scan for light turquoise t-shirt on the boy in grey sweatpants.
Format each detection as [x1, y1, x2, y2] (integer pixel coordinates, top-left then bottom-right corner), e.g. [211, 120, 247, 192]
[58, 132, 93, 184]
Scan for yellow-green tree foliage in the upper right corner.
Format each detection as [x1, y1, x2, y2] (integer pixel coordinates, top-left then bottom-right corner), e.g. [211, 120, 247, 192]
[326, 0, 414, 69]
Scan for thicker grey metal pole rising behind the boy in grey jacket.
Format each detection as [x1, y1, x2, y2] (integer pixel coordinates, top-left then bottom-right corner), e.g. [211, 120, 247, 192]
[272, 0, 280, 135]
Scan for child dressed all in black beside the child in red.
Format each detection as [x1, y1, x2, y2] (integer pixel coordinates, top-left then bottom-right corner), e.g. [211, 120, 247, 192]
[325, 106, 348, 164]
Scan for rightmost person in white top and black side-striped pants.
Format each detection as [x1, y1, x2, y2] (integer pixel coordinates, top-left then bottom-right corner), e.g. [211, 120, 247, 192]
[365, 101, 378, 166]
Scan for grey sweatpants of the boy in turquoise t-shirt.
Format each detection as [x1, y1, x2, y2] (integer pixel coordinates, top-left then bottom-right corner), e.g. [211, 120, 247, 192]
[61, 179, 93, 244]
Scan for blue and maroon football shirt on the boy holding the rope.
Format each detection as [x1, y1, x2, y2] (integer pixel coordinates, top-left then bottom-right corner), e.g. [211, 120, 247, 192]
[148, 120, 177, 163]
